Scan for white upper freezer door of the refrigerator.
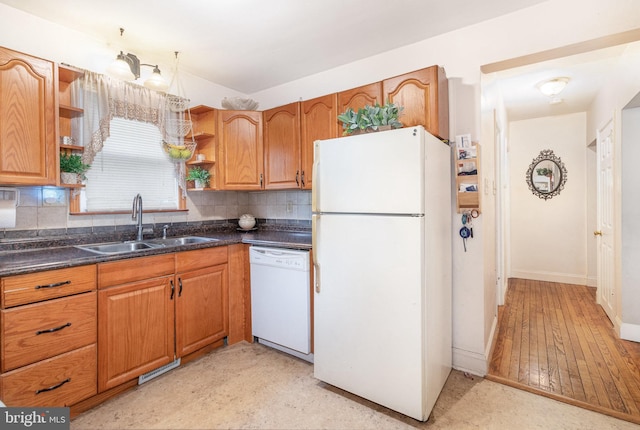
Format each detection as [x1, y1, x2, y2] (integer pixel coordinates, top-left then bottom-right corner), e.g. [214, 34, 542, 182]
[312, 126, 428, 214]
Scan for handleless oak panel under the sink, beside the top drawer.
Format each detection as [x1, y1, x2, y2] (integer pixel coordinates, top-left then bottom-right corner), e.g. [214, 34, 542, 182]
[98, 254, 175, 288]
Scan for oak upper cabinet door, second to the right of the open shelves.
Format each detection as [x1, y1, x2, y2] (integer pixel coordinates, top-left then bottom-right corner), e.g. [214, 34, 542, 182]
[263, 102, 301, 190]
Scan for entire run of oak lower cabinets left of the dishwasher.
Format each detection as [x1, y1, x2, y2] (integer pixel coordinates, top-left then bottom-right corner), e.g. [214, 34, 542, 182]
[0, 244, 250, 416]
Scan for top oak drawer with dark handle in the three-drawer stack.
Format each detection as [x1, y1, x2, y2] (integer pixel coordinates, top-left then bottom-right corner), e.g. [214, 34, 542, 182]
[0, 264, 96, 308]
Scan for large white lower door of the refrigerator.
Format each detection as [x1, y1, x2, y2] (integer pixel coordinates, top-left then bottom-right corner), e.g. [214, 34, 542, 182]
[314, 213, 428, 420]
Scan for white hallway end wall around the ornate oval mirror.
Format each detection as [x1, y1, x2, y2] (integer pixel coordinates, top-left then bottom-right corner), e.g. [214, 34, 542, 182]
[509, 113, 587, 285]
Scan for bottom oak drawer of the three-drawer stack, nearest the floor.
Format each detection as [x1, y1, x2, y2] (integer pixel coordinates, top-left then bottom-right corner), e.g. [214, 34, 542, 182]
[0, 344, 97, 406]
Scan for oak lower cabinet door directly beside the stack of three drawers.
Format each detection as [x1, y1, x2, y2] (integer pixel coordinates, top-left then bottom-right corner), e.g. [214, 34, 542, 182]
[98, 276, 174, 392]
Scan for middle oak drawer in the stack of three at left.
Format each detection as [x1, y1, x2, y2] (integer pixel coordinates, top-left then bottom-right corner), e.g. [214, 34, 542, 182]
[0, 291, 97, 372]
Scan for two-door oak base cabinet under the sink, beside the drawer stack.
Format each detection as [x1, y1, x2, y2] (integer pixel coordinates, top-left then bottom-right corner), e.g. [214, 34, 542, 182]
[98, 246, 229, 392]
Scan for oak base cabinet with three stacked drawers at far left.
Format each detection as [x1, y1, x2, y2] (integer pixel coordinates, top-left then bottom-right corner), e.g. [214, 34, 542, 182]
[0, 265, 97, 407]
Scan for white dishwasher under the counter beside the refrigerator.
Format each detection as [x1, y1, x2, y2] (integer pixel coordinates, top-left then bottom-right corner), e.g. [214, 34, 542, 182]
[249, 246, 313, 362]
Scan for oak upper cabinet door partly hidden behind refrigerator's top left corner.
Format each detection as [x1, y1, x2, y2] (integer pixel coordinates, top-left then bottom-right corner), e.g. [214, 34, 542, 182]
[300, 94, 339, 190]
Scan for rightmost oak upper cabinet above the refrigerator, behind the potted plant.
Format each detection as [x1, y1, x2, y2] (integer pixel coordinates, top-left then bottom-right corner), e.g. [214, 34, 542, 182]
[382, 66, 449, 139]
